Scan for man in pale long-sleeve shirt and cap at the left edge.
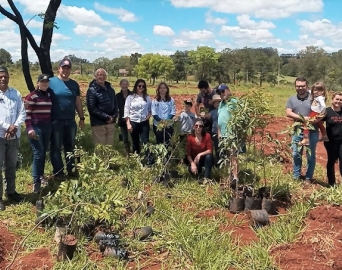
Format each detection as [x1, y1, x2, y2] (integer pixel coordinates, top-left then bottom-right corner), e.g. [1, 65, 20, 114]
[0, 67, 26, 211]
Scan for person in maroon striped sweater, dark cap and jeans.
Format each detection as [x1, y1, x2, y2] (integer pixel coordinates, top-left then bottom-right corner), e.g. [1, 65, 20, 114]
[25, 74, 52, 193]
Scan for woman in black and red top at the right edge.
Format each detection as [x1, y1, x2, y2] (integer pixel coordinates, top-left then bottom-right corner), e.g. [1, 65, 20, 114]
[323, 92, 342, 187]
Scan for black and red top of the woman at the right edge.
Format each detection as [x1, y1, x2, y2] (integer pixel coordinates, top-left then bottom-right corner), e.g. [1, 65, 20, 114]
[323, 107, 342, 141]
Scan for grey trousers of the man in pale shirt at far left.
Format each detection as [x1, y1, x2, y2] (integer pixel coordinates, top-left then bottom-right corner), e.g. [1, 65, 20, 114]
[0, 138, 20, 199]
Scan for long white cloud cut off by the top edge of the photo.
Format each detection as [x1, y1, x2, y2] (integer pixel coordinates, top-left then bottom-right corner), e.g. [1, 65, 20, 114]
[170, 0, 323, 19]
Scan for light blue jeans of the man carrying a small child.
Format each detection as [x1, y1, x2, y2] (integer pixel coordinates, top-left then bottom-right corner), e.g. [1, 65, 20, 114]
[292, 130, 319, 179]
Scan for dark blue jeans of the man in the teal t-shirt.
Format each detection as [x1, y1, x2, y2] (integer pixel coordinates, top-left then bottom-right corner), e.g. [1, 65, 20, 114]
[50, 119, 77, 175]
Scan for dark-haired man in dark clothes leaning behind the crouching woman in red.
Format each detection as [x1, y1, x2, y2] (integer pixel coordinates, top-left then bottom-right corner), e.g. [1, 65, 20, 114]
[195, 80, 215, 135]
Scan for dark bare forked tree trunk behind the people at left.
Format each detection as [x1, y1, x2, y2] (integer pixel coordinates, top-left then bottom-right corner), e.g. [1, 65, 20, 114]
[0, 0, 62, 91]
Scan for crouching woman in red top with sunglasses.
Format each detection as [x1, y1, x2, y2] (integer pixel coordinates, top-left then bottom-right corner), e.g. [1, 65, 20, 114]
[186, 119, 213, 179]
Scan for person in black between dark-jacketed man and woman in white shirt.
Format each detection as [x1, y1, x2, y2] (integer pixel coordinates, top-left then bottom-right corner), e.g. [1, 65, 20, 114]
[116, 79, 132, 157]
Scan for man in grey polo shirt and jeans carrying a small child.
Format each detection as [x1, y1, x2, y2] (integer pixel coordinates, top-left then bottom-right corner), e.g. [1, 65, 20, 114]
[286, 77, 319, 186]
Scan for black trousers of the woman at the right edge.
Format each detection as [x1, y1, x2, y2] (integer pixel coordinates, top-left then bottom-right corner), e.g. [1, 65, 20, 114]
[324, 141, 342, 186]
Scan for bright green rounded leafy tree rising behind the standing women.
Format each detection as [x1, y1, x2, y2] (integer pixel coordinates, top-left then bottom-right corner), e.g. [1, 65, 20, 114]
[134, 53, 174, 84]
